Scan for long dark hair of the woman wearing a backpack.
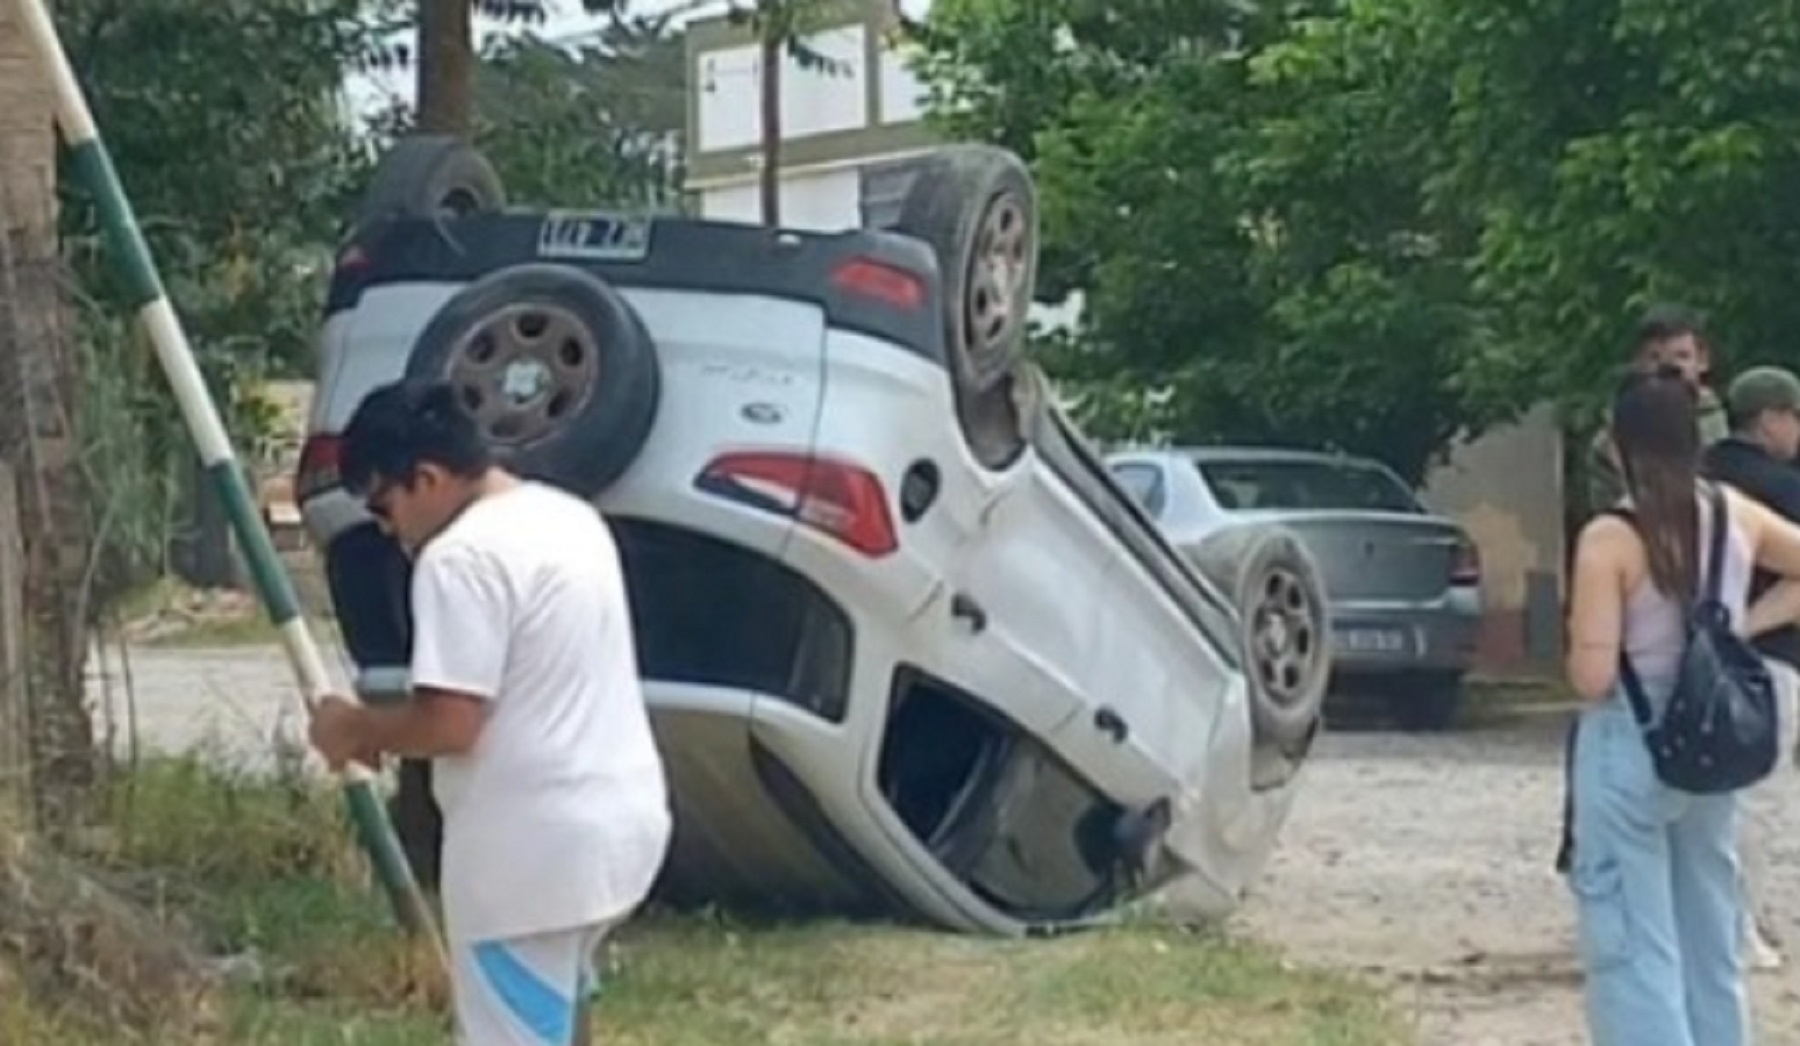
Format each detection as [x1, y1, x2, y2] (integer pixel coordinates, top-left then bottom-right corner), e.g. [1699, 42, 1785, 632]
[1613, 367, 1699, 601]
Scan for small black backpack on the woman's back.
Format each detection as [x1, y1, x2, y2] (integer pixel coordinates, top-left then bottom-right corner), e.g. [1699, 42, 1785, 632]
[1607, 484, 1780, 796]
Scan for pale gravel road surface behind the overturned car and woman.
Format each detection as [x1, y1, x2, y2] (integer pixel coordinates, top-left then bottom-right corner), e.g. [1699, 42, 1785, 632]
[95, 648, 1800, 1046]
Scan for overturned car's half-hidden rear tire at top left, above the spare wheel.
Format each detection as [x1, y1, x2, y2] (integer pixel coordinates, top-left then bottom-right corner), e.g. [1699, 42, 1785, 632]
[353, 135, 506, 225]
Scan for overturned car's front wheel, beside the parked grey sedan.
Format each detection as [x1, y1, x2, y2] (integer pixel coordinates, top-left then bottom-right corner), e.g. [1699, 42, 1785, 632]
[1193, 524, 1332, 753]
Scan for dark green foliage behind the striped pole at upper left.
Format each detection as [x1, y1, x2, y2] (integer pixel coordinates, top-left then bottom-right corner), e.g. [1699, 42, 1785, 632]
[56, 0, 391, 601]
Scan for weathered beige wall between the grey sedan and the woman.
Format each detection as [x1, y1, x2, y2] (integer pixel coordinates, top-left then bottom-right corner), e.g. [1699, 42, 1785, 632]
[1424, 405, 1564, 673]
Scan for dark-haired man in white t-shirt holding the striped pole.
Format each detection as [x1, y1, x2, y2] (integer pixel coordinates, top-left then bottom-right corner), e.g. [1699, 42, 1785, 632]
[311, 382, 671, 1046]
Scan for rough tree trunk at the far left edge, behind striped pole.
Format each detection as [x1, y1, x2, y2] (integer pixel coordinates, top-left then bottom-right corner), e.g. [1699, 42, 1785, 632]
[0, 5, 97, 834]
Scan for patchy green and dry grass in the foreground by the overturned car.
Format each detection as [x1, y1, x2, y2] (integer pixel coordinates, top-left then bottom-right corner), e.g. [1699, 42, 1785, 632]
[0, 758, 1409, 1046]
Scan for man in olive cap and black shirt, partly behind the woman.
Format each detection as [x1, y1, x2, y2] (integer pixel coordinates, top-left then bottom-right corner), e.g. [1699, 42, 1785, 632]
[1705, 367, 1800, 970]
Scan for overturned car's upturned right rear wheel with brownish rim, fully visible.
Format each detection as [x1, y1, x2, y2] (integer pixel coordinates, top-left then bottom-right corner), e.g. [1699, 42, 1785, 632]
[893, 144, 1037, 400]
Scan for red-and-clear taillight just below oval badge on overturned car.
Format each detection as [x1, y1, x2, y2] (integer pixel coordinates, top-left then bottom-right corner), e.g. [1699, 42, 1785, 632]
[695, 452, 898, 556]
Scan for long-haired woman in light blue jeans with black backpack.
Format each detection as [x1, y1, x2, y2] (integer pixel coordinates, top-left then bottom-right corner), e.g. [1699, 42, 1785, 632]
[1568, 369, 1800, 1046]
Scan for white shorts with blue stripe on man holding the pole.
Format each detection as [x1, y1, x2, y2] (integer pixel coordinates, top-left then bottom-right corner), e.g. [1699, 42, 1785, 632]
[450, 924, 616, 1046]
